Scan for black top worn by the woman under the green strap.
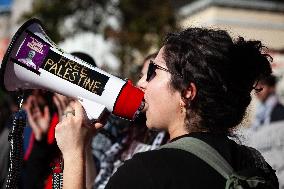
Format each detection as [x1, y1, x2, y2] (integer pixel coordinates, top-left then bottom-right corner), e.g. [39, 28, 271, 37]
[106, 133, 278, 189]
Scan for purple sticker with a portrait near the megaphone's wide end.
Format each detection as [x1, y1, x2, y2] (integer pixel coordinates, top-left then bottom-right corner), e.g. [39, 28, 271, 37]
[16, 35, 49, 71]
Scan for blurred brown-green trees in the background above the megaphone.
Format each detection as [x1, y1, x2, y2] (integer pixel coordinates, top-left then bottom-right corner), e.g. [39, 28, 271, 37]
[23, 0, 177, 78]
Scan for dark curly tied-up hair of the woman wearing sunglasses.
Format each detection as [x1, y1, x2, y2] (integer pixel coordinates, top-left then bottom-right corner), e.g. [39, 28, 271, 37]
[163, 28, 272, 133]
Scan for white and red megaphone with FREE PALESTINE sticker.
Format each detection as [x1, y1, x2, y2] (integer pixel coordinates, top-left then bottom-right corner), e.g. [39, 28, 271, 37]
[0, 18, 144, 120]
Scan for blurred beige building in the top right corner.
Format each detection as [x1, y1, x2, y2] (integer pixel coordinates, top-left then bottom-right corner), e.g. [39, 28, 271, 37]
[177, 0, 284, 99]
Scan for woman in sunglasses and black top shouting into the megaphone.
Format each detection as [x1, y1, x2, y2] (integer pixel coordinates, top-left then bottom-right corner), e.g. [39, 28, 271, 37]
[56, 28, 278, 189]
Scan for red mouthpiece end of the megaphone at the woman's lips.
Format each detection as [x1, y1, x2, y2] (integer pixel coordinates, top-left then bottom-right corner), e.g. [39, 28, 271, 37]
[113, 81, 144, 120]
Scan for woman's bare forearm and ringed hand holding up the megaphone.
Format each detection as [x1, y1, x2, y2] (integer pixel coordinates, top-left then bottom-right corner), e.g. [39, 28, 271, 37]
[55, 101, 103, 189]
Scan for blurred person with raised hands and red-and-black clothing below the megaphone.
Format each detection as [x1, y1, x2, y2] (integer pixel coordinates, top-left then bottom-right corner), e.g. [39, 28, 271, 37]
[20, 89, 59, 189]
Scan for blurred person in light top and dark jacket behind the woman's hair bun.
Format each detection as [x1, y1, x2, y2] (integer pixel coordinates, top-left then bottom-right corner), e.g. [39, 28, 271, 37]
[252, 75, 284, 130]
